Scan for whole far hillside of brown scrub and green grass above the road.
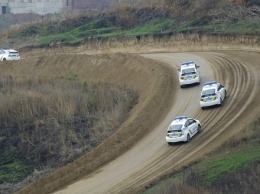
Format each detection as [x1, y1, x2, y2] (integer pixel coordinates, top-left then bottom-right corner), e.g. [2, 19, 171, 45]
[2, 0, 260, 47]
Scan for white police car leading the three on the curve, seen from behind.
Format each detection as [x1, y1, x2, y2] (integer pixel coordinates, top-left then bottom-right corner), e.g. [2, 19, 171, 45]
[178, 61, 200, 88]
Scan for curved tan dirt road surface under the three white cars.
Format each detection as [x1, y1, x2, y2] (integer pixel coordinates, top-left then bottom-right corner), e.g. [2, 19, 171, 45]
[53, 51, 260, 194]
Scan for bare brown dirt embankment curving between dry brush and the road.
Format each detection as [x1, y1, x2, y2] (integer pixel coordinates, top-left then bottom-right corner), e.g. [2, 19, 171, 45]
[10, 50, 175, 193]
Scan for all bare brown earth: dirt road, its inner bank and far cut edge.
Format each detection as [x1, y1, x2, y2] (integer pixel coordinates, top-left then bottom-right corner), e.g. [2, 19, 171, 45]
[11, 36, 260, 194]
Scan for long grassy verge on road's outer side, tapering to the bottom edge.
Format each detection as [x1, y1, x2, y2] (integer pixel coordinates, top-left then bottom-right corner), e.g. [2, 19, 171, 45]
[143, 144, 260, 194]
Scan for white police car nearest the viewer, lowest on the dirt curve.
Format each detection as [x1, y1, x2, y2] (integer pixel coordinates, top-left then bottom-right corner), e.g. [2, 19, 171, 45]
[166, 116, 201, 145]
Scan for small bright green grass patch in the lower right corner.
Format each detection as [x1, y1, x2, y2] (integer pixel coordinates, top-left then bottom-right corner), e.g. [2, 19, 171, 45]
[203, 144, 260, 184]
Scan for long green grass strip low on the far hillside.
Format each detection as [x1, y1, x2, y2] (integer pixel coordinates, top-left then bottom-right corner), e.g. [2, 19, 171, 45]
[34, 18, 260, 46]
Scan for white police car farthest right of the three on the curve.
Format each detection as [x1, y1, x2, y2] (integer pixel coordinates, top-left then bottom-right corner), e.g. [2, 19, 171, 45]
[200, 81, 227, 109]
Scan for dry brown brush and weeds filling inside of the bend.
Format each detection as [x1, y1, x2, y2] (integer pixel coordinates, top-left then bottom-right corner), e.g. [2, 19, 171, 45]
[0, 74, 138, 193]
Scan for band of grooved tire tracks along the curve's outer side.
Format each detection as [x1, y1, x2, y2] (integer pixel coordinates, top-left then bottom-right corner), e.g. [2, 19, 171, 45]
[100, 53, 258, 193]
